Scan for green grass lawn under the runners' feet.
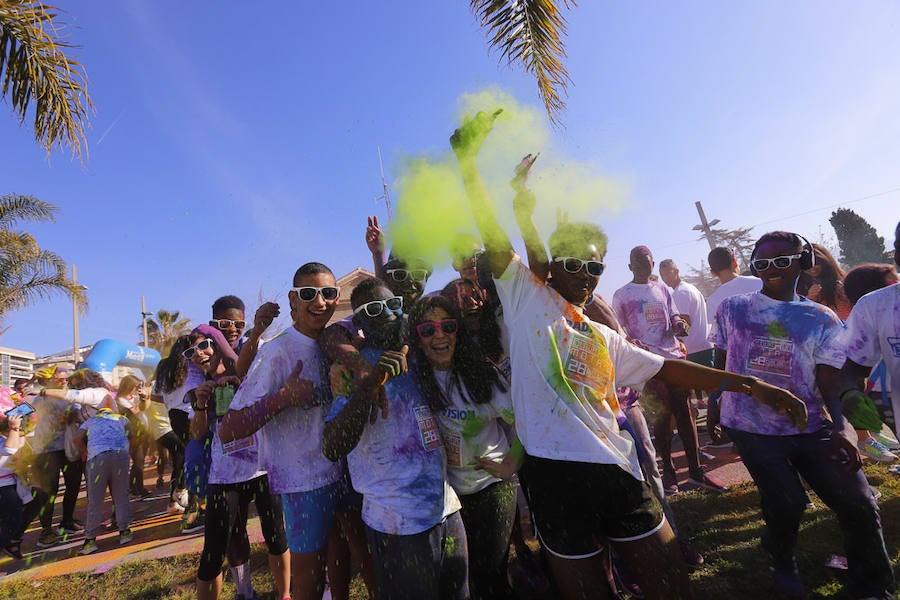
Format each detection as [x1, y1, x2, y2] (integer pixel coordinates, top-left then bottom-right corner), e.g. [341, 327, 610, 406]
[0, 465, 900, 600]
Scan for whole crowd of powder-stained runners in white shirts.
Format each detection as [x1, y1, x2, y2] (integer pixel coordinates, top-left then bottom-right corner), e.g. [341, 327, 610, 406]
[0, 114, 900, 600]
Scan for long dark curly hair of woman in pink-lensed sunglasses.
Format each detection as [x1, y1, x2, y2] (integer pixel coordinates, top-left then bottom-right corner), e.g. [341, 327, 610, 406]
[409, 296, 506, 410]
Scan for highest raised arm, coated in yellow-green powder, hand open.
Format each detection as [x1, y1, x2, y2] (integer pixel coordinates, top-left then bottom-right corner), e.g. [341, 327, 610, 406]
[450, 109, 514, 277]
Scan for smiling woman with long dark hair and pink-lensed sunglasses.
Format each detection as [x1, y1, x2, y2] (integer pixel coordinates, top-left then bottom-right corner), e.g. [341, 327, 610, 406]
[409, 296, 524, 598]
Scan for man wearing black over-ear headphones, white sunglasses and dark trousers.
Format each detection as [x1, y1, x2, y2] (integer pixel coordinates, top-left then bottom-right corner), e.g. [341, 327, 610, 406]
[710, 231, 894, 598]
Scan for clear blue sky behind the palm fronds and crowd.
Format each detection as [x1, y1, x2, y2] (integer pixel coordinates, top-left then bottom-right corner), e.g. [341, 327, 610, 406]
[0, 0, 900, 355]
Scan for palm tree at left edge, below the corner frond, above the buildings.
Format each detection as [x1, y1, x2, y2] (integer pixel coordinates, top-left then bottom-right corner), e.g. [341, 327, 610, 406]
[0, 194, 87, 334]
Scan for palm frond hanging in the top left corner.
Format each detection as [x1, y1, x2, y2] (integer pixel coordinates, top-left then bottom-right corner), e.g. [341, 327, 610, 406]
[0, 0, 94, 159]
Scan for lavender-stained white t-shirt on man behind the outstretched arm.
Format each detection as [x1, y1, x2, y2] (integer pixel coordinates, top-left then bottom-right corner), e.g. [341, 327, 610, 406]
[613, 281, 684, 358]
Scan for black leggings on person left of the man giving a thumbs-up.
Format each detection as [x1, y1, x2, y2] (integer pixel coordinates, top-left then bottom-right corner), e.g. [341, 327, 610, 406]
[197, 475, 288, 581]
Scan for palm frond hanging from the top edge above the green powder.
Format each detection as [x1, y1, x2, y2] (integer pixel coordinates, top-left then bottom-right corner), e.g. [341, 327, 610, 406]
[469, 0, 577, 125]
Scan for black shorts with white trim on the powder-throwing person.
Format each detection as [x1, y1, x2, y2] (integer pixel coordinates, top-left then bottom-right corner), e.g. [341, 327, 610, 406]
[521, 456, 665, 559]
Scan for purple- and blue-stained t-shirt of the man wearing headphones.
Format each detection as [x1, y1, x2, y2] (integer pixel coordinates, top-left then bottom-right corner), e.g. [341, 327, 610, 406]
[709, 292, 844, 435]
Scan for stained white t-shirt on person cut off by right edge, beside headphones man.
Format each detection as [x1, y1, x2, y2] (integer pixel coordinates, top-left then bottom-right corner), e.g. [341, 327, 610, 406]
[842, 284, 900, 398]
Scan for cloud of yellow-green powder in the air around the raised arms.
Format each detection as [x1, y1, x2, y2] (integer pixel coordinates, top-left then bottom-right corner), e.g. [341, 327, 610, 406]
[387, 89, 625, 266]
